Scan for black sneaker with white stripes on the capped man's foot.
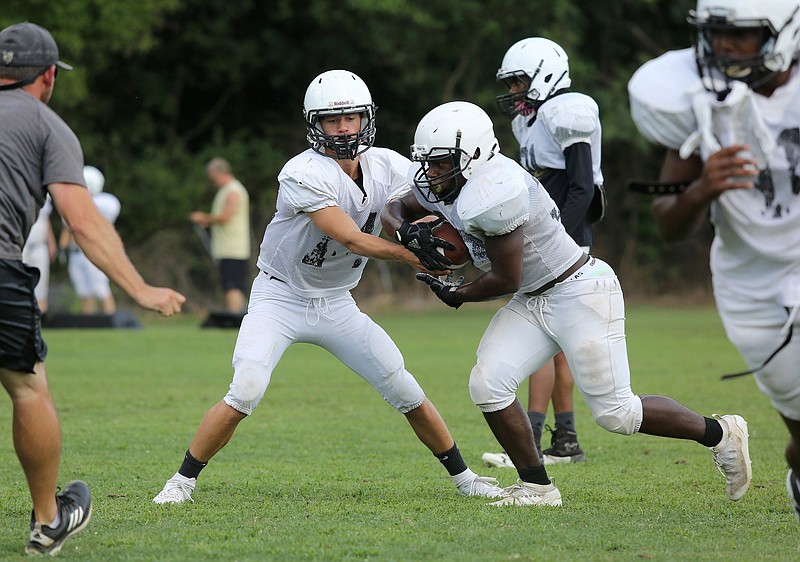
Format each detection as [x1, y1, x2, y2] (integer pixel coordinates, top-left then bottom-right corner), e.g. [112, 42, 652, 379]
[25, 480, 92, 556]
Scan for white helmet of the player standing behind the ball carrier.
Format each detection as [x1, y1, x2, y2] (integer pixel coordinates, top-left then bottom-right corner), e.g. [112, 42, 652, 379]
[497, 37, 572, 117]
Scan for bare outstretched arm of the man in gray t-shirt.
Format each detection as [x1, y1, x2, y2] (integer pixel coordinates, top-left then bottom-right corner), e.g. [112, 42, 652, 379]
[48, 183, 186, 316]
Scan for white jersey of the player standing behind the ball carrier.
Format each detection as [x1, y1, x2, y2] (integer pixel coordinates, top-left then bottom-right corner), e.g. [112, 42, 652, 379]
[511, 92, 603, 185]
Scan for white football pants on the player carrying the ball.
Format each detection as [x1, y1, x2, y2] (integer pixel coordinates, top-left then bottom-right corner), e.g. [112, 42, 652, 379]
[469, 258, 642, 435]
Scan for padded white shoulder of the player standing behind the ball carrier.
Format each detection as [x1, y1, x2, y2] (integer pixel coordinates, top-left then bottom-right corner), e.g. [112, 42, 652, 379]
[536, 92, 600, 151]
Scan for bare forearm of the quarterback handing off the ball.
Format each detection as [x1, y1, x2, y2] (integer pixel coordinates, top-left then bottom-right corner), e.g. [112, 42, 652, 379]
[308, 207, 427, 271]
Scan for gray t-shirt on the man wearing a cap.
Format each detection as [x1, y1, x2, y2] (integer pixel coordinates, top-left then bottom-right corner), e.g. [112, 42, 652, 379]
[0, 90, 85, 260]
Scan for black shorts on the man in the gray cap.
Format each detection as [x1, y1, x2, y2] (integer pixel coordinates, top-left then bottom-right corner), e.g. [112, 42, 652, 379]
[0, 259, 47, 373]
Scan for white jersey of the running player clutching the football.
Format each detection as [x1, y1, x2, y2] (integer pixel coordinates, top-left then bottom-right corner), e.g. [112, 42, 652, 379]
[412, 154, 581, 293]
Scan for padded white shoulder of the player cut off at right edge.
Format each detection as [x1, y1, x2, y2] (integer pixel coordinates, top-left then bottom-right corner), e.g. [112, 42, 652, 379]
[628, 49, 702, 150]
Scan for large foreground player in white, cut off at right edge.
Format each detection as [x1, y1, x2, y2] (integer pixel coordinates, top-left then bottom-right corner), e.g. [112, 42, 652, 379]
[628, 0, 800, 517]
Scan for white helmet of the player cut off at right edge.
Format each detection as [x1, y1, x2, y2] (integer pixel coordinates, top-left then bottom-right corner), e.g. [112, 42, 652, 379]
[687, 0, 800, 94]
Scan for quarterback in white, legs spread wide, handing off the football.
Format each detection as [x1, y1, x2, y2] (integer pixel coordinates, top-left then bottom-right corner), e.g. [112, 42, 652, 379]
[153, 70, 504, 503]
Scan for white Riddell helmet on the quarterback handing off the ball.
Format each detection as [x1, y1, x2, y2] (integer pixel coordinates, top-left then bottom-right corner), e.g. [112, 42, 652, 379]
[303, 70, 377, 160]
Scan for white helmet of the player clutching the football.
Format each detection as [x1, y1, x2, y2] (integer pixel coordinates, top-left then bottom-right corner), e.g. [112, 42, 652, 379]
[411, 101, 500, 203]
